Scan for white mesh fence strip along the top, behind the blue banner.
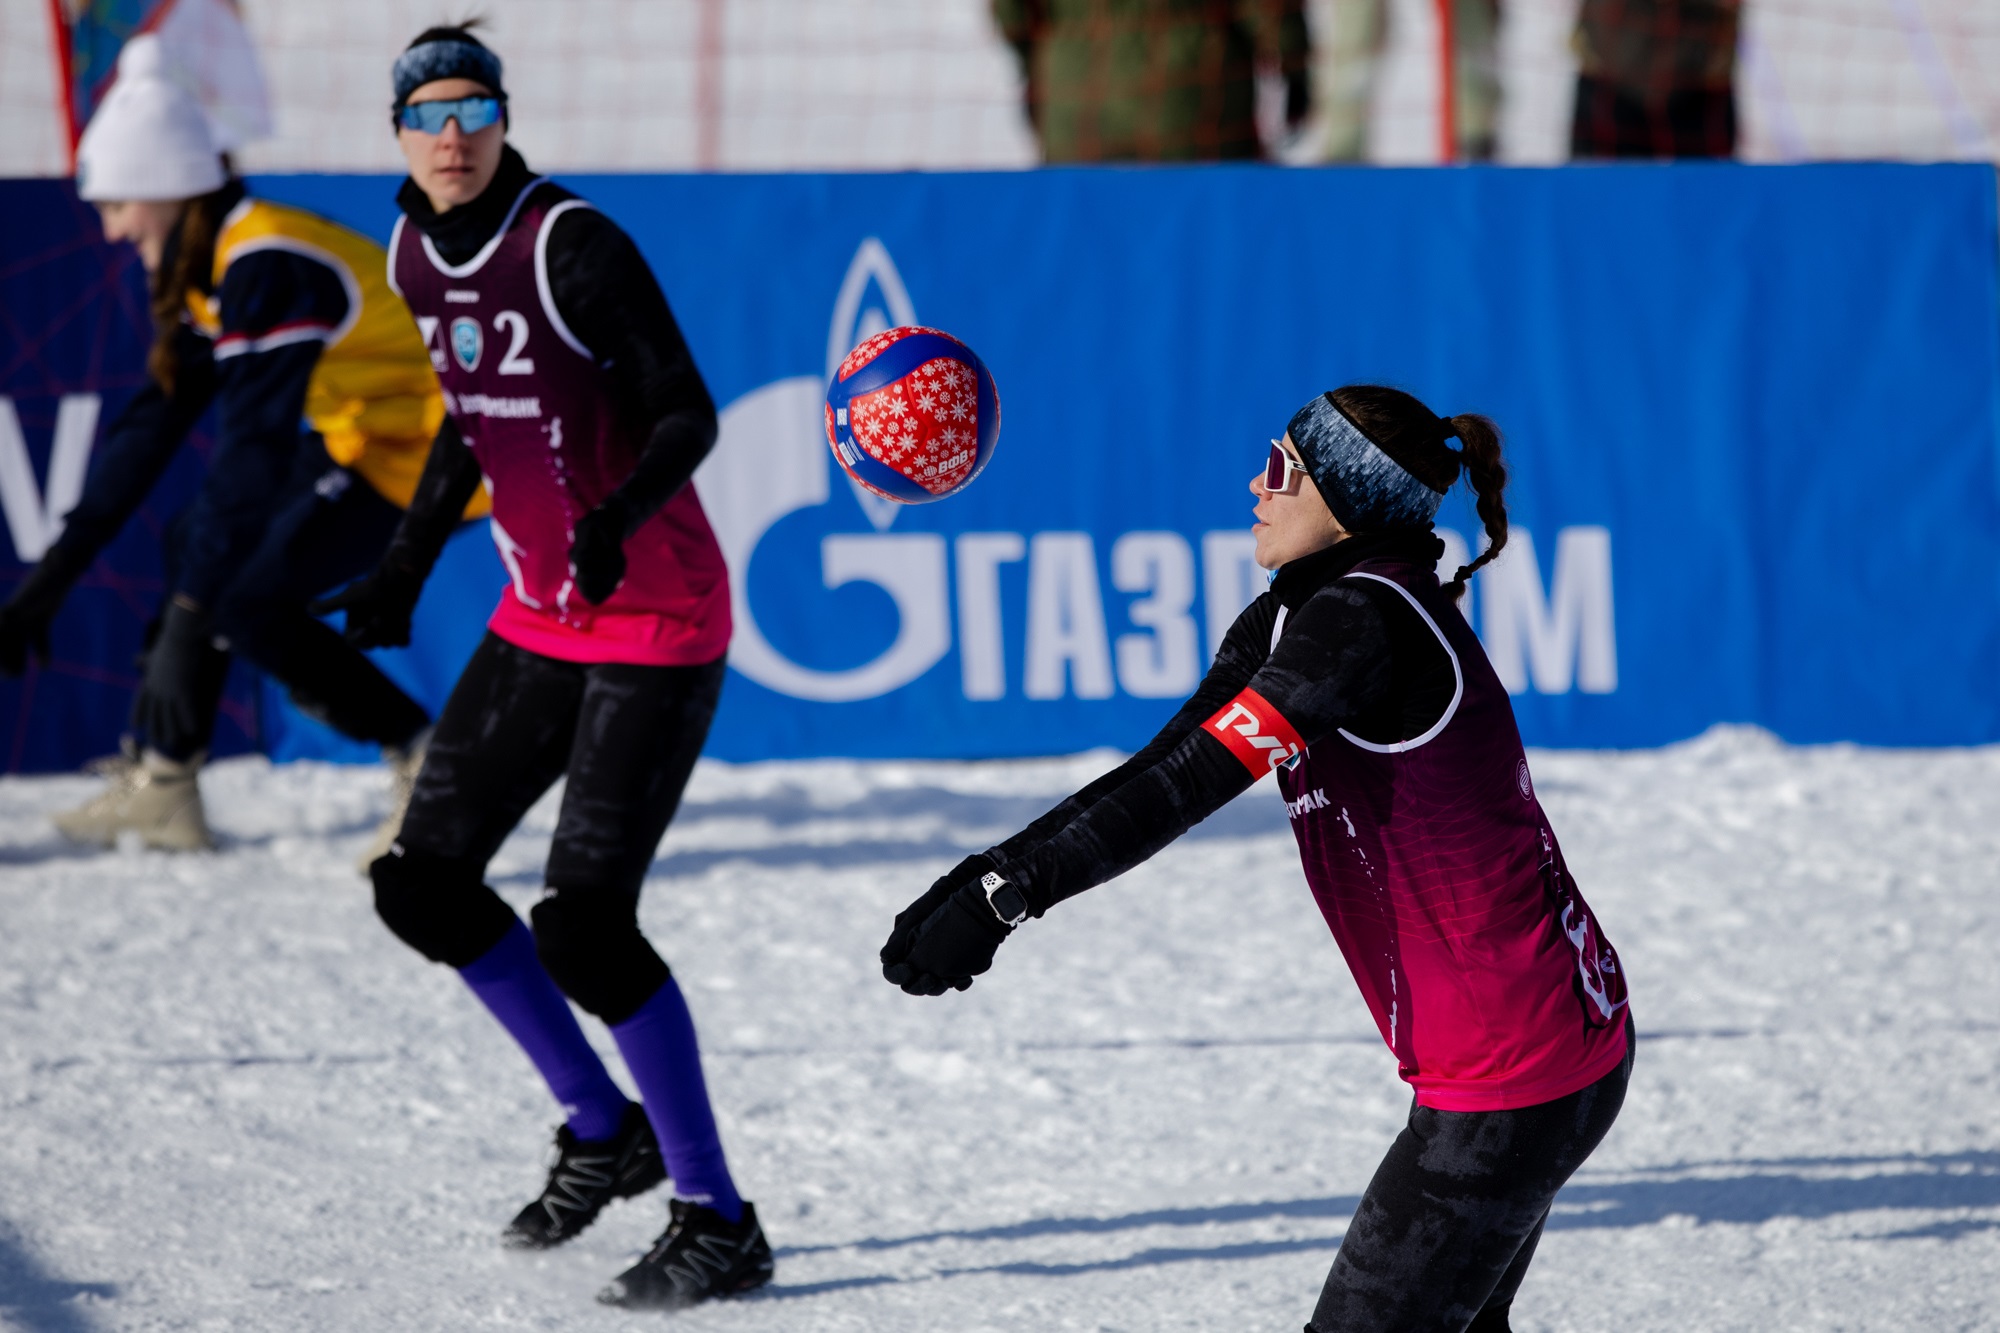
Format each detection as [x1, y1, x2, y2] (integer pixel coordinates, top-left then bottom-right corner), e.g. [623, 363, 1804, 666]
[0, 0, 2000, 176]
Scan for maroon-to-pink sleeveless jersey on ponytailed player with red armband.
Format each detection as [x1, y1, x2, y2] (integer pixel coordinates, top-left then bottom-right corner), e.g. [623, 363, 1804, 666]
[1278, 560, 1626, 1111]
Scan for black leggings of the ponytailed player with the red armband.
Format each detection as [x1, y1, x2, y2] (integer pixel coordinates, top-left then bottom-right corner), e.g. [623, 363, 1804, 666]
[1306, 1021, 1638, 1333]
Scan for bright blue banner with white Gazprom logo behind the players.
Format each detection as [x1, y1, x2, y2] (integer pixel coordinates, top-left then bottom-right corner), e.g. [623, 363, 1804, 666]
[0, 164, 2000, 759]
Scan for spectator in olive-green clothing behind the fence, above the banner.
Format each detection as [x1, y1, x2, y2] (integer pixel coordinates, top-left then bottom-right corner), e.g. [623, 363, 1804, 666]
[992, 0, 1312, 162]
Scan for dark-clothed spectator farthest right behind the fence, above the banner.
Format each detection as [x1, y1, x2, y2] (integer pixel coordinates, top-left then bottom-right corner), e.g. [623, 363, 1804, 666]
[1570, 0, 1742, 158]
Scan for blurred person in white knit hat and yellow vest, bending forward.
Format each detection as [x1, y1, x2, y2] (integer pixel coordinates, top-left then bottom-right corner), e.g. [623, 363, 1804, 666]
[0, 36, 484, 849]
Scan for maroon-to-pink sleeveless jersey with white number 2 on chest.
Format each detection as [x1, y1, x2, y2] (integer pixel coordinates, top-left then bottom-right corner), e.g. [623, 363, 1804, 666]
[388, 180, 730, 667]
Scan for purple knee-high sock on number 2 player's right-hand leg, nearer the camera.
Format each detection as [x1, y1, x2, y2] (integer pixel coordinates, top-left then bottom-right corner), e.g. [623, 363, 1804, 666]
[612, 977, 744, 1221]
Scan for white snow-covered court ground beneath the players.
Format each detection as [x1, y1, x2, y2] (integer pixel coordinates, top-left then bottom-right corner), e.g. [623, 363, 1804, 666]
[0, 731, 2000, 1333]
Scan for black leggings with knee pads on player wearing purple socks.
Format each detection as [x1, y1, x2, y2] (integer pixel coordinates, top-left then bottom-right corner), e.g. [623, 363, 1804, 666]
[372, 632, 722, 1023]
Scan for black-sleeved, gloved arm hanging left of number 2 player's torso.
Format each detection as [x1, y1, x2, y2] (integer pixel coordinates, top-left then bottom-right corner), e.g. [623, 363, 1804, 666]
[308, 416, 480, 648]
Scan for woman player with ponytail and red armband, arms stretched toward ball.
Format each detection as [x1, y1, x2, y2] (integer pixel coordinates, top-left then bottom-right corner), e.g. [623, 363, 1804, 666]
[882, 386, 1634, 1333]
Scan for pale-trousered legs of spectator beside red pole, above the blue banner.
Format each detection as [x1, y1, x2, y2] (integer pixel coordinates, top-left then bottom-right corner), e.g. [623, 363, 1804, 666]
[1320, 0, 1500, 162]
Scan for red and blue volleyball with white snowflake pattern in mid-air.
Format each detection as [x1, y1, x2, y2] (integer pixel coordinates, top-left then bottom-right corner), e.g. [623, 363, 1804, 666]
[826, 324, 1000, 504]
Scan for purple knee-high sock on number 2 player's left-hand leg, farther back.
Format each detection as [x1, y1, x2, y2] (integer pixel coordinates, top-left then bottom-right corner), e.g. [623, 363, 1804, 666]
[458, 921, 630, 1141]
